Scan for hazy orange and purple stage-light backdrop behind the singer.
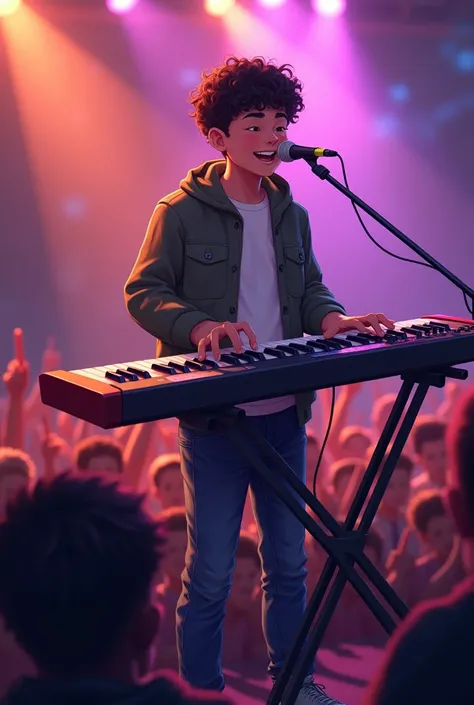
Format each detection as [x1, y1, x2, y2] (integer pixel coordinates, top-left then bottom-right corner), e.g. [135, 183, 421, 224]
[0, 0, 474, 380]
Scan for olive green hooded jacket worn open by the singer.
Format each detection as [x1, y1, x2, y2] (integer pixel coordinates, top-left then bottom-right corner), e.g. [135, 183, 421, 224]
[125, 160, 345, 424]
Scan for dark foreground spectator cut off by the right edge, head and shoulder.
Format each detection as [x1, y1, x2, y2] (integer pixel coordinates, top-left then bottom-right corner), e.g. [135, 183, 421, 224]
[364, 388, 474, 705]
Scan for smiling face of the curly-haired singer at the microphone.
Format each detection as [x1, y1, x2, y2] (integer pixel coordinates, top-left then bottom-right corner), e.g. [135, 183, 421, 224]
[213, 109, 288, 177]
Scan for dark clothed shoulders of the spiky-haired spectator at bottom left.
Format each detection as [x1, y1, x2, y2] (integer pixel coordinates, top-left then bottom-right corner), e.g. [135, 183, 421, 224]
[2, 676, 188, 705]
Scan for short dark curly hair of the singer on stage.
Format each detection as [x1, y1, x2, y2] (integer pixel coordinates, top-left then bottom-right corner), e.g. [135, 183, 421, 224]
[190, 56, 304, 137]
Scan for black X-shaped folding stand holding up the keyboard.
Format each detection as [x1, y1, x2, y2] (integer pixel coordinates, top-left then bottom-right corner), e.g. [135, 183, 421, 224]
[195, 367, 468, 705]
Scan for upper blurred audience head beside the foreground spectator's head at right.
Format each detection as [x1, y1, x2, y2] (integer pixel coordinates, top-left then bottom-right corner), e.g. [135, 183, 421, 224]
[411, 416, 446, 488]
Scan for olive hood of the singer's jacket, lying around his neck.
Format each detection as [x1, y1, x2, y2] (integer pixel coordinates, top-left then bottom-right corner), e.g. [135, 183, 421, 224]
[179, 159, 293, 223]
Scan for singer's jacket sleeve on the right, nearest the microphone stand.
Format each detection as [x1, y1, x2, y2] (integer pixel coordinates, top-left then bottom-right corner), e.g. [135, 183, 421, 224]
[301, 214, 346, 335]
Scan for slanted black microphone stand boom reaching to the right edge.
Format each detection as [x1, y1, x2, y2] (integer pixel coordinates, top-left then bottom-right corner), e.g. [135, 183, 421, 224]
[305, 159, 474, 320]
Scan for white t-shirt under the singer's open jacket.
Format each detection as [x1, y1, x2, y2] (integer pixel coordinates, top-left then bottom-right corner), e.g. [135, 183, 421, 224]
[232, 194, 295, 416]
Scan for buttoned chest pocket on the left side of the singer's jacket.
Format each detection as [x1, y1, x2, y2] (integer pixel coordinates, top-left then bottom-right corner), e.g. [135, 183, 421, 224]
[183, 244, 229, 300]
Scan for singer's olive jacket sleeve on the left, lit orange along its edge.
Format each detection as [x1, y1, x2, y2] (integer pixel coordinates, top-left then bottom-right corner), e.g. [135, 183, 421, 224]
[125, 203, 217, 351]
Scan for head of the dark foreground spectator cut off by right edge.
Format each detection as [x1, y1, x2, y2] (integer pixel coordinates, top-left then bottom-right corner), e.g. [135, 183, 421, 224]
[447, 387, 474, 573]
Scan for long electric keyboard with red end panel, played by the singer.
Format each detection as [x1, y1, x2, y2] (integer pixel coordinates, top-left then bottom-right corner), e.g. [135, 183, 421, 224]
[39, 315, 474, 428]
